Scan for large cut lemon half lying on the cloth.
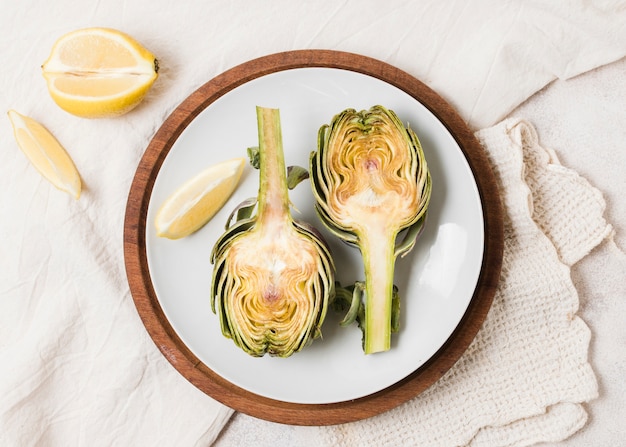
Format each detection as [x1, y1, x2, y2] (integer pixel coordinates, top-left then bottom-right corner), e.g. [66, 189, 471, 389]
[42, 28, 159, 118]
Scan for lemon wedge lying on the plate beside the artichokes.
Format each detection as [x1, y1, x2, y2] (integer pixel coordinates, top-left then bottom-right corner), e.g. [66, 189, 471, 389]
[155, 157, 245, 239]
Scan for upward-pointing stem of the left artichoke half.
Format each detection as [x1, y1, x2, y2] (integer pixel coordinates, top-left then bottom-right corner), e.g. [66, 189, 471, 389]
[257, 107, 291, 227]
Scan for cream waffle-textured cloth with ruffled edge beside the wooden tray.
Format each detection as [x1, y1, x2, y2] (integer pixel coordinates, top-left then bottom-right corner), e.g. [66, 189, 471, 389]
[319, 120, 612, 447]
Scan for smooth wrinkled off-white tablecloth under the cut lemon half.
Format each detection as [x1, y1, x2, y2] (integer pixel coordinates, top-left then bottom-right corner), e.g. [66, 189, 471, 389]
[0, 0, 626, 446]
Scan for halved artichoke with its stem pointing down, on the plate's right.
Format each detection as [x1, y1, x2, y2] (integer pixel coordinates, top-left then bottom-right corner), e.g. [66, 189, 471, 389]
[310, 106, 432, 354]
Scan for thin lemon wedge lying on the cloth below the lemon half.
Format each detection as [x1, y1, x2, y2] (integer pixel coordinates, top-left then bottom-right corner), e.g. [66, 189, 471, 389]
[8, 110, 81, 199]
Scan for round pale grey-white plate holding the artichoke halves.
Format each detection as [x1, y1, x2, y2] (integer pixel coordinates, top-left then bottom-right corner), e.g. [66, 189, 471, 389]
[146, 67, 484, 404]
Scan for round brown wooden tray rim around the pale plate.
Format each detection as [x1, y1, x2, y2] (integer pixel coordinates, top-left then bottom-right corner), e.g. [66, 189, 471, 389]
[124, 50, 503, 425]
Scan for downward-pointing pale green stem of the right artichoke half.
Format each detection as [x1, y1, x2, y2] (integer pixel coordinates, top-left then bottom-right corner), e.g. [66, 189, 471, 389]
[360, 229, 395, 354]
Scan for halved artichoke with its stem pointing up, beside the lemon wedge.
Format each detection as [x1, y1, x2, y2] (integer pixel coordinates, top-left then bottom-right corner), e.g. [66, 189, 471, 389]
[211, 107, 334, 357]
